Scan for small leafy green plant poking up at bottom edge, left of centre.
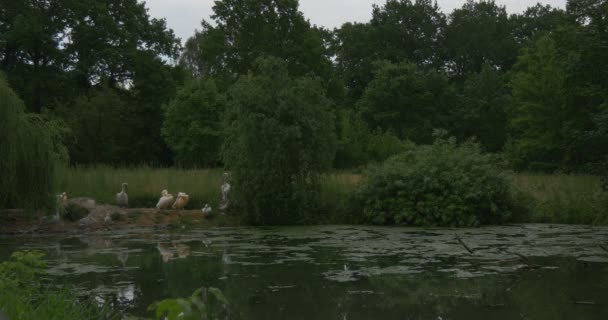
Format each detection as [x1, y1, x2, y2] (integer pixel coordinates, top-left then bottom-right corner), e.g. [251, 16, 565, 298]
[148, 287, 228, 320]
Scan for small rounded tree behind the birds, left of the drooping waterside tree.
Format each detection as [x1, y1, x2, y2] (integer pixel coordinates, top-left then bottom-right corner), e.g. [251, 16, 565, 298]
[162, 80, 226, 167]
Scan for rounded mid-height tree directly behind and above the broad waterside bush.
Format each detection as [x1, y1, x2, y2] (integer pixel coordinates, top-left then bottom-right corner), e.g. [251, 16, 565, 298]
[357, 61, 455, 143]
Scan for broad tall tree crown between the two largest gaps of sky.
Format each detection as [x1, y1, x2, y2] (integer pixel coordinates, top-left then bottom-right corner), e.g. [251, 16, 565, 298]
[182, 0, 331, 79]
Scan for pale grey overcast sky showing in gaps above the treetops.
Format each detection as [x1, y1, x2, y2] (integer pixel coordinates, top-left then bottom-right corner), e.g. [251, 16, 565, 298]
[145, 0, 566, 42]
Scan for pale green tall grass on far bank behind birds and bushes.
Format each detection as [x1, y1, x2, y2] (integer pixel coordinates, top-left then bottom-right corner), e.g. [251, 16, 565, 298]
[59, 166, 608, 224]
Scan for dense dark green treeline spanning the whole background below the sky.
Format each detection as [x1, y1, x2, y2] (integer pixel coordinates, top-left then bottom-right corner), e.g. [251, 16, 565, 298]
[0, 0, 608, 174]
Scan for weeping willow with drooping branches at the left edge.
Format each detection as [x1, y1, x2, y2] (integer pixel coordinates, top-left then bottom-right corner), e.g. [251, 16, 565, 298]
[0, 78, 57, 208]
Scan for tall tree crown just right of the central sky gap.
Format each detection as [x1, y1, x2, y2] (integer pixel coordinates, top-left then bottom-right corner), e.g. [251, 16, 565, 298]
[334, 0, 446, 105]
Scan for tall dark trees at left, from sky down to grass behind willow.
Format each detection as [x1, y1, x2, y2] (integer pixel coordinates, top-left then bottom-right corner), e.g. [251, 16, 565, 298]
[0, 0, 183, 163]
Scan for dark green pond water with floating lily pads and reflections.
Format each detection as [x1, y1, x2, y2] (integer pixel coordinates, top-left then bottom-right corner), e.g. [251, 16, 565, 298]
[0, 224, 608, 320]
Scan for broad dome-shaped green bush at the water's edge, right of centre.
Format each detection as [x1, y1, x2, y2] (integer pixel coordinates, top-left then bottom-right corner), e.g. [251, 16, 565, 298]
[356, 137, 515, 227]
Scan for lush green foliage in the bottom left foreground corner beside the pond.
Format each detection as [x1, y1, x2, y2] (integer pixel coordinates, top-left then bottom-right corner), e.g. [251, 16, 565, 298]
[0, 252, 118, 320]
